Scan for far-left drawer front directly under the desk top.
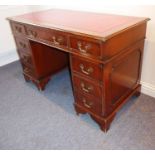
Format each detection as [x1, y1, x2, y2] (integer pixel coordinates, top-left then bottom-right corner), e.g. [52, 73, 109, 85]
[11, 23, 25, 35]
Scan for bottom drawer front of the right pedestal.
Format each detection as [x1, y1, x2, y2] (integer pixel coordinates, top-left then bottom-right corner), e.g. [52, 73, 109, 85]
[75, 92, 102, 115]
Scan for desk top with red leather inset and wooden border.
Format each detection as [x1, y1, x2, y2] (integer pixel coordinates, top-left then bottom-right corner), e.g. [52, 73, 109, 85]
[8, 9, 149, 41]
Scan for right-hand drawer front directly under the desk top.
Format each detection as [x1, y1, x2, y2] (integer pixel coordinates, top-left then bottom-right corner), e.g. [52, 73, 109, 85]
[70, 37, 101, 58]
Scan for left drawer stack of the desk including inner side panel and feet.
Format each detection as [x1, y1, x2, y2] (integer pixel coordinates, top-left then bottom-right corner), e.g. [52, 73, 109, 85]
[11, 23, 68, 90]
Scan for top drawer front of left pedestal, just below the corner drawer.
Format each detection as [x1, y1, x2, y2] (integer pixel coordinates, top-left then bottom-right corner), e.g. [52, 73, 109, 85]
[15, 37, 30, 53]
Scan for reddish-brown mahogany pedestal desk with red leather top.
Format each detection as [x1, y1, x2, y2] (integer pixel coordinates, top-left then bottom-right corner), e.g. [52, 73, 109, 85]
[8, 9, 149, 132]
